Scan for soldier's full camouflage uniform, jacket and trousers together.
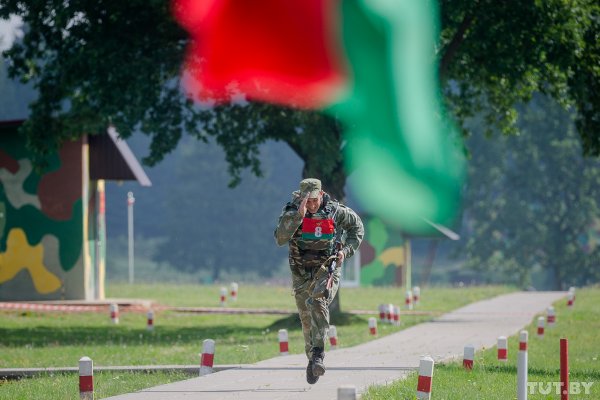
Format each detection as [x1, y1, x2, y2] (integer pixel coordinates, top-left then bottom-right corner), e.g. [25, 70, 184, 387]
[275, 184, 364, 360]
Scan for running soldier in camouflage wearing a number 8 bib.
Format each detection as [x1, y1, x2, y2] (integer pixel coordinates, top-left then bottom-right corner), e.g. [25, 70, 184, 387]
[275, 178, 364, 384]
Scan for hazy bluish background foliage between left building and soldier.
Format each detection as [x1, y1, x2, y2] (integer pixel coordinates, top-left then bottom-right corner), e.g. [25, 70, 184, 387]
[106, 135, 301, 281]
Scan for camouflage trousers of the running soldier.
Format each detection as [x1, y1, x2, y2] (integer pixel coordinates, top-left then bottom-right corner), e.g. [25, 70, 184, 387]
[291, 264, 341, 360]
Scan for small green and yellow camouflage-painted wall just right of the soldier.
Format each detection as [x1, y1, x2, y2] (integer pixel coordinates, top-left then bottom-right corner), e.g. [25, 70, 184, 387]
[360, 217, 410, 286]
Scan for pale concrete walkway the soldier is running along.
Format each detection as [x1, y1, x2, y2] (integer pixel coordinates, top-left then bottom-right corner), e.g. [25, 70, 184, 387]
[110, 292, 566, 400]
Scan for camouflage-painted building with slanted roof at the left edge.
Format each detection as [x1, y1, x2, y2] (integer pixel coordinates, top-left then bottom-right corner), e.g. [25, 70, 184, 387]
[0, 120, 151, 301]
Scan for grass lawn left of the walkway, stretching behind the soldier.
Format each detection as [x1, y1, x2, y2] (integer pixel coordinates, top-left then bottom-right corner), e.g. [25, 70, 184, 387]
[0, 284, 511, 399]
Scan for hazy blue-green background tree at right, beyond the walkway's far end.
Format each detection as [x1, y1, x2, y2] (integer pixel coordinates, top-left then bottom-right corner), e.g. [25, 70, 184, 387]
[463, 96, 600, 290]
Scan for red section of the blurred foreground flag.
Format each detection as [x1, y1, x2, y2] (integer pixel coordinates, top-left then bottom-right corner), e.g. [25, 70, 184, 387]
[173, 0, 345, 108]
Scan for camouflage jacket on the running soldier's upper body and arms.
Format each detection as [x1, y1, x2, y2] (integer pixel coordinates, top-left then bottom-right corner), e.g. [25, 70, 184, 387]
[275, 191, 365, 258]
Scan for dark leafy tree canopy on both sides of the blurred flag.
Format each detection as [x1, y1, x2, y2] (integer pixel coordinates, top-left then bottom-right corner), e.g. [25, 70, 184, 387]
[0, 0, 600, 199]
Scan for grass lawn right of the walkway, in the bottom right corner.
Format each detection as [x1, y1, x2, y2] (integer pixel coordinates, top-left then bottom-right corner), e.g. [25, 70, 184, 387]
[361, 288, 600, 400]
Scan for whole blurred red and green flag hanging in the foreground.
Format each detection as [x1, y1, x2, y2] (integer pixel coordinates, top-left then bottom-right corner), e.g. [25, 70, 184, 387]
[173, 0, 464, 234]
